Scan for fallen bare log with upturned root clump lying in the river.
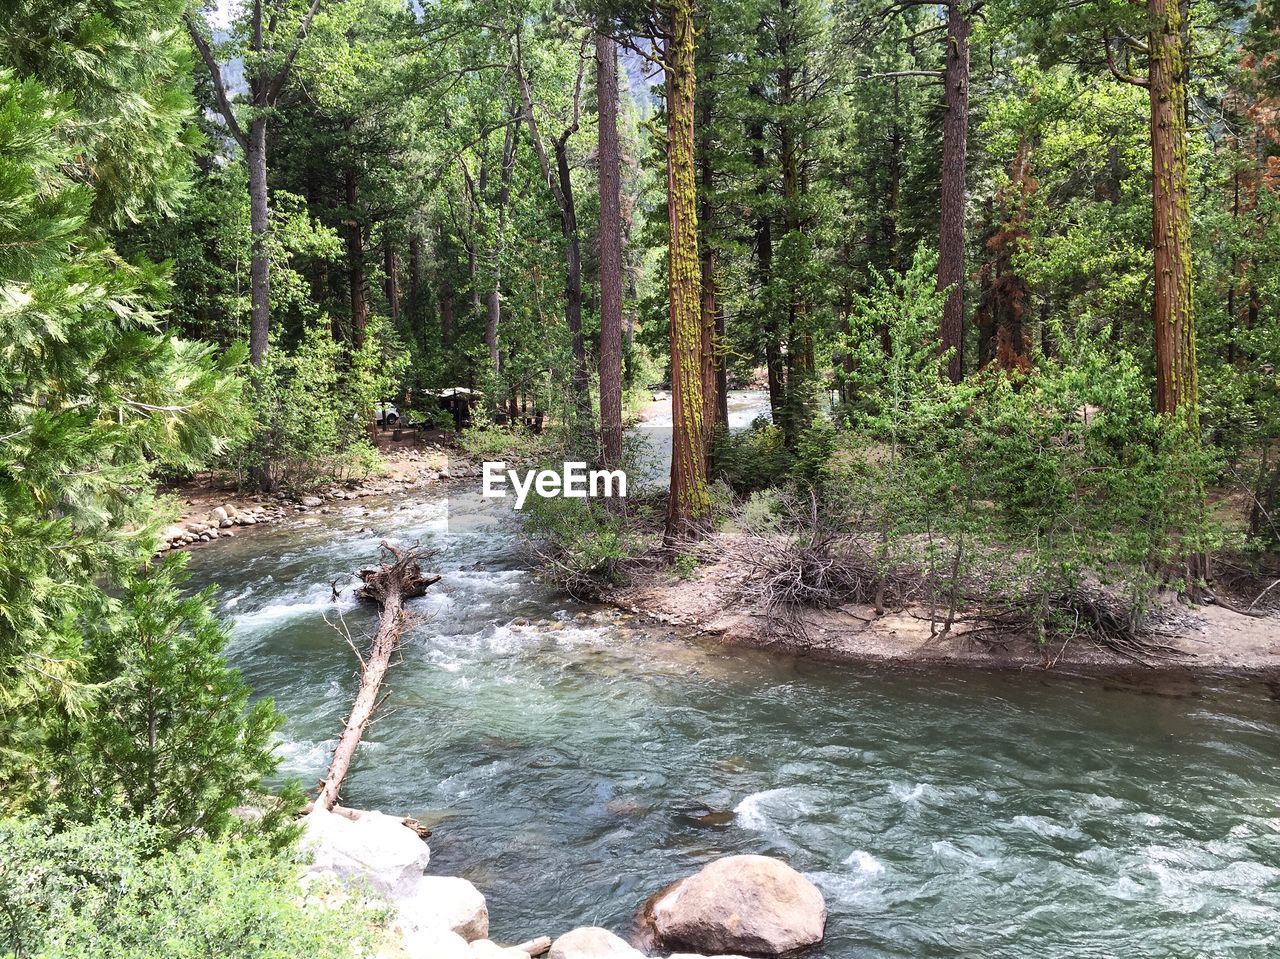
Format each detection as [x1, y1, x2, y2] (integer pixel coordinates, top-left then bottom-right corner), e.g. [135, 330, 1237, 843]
[315, 540, 440, 810]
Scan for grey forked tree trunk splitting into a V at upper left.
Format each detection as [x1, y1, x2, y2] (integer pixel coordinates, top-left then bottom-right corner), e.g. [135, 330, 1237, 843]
[186, 0, 323, 366]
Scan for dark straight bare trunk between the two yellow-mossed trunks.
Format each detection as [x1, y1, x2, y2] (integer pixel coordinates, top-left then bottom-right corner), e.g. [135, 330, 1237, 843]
[938, 0, 972, 383]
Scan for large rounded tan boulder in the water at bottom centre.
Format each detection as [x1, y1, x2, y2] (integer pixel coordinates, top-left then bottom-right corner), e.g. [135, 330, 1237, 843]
[644, 855, 827, 955]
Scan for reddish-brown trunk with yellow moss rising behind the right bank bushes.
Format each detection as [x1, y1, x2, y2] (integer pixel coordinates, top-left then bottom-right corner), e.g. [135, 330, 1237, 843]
[1147, 0, 1197, 417]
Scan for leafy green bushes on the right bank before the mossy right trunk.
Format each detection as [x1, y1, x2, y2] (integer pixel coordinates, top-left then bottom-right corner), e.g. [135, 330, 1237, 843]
[823, 250, 1221, 632]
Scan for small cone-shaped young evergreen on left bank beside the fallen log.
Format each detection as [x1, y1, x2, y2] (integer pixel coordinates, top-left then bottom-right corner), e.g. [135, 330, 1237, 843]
[50, 554, 284, 836]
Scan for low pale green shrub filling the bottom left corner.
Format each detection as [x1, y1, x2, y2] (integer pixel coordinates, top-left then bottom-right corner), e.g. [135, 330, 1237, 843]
[0, 818, 384, 959]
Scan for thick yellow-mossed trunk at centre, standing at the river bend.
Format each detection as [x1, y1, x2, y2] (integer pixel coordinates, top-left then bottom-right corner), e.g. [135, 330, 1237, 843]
[663, 0, 710, 542]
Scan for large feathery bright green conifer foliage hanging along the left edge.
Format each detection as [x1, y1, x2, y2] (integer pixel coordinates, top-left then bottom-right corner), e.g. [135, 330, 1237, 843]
[0, 63, 243, 782]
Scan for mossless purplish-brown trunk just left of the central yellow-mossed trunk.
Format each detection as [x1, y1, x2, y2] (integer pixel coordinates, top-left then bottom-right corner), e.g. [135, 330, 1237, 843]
[595, 33, 622, 469]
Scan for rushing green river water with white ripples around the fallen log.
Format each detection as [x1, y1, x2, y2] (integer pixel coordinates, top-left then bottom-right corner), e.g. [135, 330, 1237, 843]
[192, 489, 1280, 959]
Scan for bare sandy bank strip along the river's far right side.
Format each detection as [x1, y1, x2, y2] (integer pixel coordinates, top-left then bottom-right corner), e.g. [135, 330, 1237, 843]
[604, 533, 1280, 679]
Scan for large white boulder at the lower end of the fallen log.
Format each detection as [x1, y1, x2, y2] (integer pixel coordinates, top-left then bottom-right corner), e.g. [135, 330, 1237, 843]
[302, 807, 431, 898]
